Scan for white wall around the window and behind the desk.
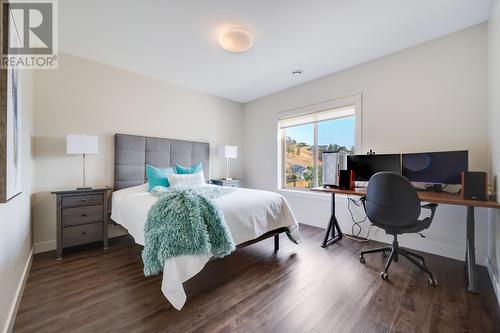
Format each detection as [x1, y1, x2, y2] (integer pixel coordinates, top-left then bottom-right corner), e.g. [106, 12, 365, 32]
[243, 24, 489, 264]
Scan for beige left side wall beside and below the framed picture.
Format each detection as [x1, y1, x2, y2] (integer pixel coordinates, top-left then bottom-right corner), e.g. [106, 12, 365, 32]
[0, 70, 33, 332]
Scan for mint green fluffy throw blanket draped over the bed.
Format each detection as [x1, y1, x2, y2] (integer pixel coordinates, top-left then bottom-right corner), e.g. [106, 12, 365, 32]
[142, 188, 235, 276]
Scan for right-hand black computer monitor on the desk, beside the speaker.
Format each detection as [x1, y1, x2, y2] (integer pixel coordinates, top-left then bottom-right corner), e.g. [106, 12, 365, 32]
[403, 150, 469, 184]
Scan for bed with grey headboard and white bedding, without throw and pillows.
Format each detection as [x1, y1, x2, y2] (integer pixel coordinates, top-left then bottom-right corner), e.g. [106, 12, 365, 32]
[111, 134, 300, 310]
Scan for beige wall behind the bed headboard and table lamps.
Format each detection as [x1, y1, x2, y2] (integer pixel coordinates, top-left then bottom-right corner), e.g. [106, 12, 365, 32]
[33, 54, 244, 251]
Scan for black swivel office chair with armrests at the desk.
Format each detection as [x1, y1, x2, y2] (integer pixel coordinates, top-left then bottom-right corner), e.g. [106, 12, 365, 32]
[359, 172, 437, 286]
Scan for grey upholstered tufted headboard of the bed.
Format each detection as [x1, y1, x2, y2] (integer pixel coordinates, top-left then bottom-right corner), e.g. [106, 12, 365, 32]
[114, 134, 210, 191]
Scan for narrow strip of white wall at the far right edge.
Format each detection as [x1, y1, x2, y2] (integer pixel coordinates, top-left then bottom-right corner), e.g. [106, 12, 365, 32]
[488, 0, 500, 303]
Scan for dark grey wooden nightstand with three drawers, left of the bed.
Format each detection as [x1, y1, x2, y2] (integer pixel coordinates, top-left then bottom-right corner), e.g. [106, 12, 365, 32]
[52, 187, 111, 260]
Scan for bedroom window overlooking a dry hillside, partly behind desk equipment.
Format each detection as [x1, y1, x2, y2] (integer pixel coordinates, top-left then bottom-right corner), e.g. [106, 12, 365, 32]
[279, 105, 356, 189]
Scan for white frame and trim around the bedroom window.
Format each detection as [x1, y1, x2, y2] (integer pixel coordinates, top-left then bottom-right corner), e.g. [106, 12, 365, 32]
[277, 94, 362, 191]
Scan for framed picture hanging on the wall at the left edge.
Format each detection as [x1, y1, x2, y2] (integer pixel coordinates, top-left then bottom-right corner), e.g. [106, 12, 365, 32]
[0, 1, 22, 202]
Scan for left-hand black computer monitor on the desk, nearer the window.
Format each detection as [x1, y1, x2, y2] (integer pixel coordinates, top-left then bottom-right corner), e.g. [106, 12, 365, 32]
[347, 154, 401, 182]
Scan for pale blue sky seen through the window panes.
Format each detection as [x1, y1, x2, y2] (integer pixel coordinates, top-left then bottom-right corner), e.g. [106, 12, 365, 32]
[285, 117, 354, 148]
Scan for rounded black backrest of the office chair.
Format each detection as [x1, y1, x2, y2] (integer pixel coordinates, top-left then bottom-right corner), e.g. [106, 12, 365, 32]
[366, 172, 420, 229]
